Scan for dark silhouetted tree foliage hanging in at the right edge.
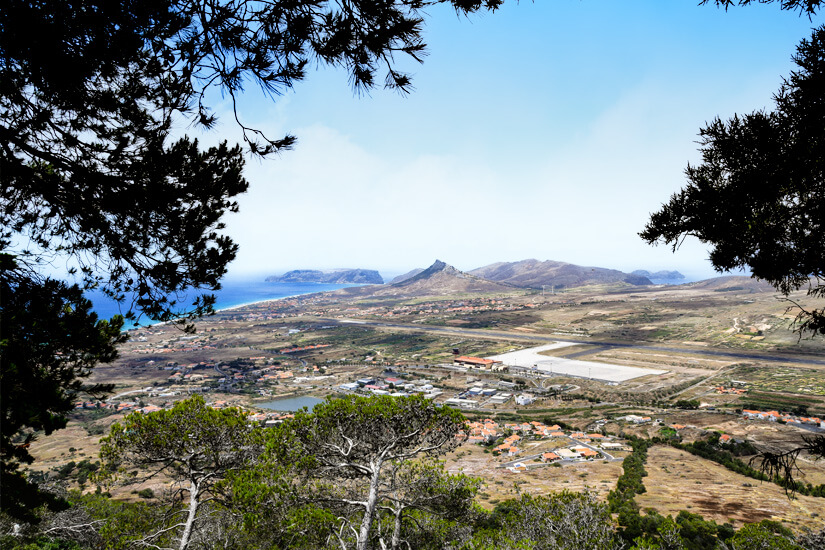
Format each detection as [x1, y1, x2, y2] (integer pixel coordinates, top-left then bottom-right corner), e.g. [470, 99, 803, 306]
[641, 27, 825, 334]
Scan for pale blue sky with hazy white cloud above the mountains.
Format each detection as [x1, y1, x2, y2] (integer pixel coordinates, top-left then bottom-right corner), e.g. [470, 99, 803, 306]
[195, 0, 823, 278]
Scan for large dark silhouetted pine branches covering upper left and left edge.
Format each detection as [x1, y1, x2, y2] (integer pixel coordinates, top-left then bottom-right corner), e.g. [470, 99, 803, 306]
[0, 0, 500, 528]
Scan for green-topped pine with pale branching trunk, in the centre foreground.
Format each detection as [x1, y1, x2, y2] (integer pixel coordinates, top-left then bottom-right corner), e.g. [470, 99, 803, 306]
[241, 396, 479, 549]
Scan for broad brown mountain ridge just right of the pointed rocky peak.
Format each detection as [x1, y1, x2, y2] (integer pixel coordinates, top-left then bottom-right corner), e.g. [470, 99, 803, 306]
[470, 259, 653, 288]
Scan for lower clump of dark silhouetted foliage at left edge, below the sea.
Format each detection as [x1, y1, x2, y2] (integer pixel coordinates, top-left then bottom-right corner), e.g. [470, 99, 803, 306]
[0, 277, 124, 521]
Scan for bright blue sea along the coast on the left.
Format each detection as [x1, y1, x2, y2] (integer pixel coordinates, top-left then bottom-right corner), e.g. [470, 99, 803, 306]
[86, 279, 358, 328]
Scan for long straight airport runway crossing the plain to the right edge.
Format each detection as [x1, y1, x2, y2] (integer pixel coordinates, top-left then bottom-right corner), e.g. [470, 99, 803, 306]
[321, 318, 825, 367]
